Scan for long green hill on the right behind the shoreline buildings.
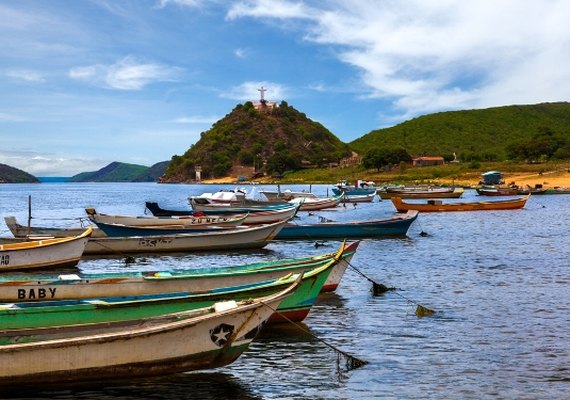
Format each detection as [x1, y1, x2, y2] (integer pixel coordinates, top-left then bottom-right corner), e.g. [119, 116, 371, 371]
[350, 102, 570, 161]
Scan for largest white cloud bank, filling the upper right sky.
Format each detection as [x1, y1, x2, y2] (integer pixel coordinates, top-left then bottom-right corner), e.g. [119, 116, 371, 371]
[226, 0, 570, 115]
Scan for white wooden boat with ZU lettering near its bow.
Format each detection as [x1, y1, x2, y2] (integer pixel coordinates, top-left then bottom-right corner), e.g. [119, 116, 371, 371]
[85, 208, 247, 228]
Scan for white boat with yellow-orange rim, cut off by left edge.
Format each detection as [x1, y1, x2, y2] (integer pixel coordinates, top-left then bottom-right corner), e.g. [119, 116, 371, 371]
[0, 228, 93, 271]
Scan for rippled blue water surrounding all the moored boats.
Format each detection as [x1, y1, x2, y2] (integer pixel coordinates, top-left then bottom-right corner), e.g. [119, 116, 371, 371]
[0, 183, 570, 400]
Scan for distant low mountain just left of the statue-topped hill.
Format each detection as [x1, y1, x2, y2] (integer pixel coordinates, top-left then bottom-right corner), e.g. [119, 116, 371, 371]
[69, 161, 168, 182]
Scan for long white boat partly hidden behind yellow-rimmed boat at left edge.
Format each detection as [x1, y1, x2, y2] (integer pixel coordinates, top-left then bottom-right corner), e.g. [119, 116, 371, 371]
[3, 218, 287, 256]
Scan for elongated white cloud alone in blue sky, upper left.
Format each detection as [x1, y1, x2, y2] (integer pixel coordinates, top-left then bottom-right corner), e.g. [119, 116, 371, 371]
[69, 56, 182, 90]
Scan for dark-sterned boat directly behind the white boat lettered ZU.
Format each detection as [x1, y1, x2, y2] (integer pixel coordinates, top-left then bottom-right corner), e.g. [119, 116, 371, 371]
[146, 201, 298, 225]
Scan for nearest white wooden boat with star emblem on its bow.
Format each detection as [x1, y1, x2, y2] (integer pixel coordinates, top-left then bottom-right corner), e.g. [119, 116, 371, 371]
[0, 282, 299, 388]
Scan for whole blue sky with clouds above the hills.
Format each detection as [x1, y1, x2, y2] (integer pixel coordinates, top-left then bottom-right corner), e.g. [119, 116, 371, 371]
[0, 0, 570, 176]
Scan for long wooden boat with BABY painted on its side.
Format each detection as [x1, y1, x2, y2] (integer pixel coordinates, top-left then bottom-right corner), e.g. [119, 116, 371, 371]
[0, 242, 359, 303]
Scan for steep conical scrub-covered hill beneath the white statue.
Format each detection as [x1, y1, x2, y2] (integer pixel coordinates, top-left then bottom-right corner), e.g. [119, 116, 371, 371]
[161, 101, 351, 182]
